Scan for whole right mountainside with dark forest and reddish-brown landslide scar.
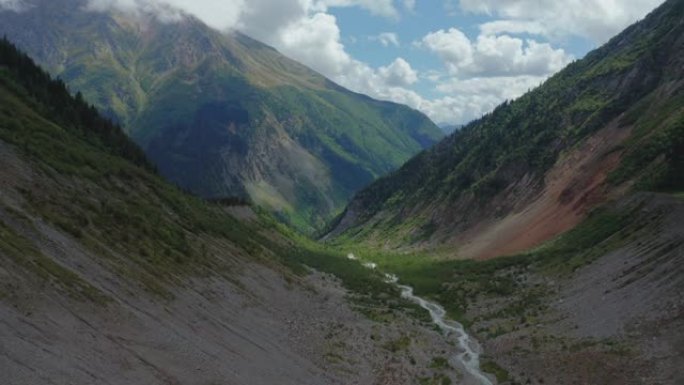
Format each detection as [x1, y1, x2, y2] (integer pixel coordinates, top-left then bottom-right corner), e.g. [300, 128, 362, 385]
[328, 1, 684, 258]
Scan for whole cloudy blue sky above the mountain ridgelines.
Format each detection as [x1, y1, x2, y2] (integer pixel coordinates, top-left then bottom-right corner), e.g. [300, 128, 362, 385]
[24, 0, 664, 124]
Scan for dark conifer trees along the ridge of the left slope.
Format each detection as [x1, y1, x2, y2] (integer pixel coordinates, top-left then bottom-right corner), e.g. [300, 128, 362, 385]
[0, 37, 156, 172]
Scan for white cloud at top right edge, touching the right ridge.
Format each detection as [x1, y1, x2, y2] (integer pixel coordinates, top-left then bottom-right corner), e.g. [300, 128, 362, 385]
[459, 0, 664, 44]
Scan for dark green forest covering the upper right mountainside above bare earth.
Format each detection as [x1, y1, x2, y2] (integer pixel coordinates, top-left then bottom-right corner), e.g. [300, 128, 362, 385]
[352, 1, 684, 216]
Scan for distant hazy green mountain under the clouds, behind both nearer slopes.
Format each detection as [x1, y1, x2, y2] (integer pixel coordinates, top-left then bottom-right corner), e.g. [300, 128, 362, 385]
[0, 0, 443, 230]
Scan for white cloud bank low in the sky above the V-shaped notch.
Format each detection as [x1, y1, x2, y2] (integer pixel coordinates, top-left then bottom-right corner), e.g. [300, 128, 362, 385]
[416, 25, 572, 123]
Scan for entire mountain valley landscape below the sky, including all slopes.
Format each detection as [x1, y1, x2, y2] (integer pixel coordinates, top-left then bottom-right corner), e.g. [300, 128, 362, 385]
[0, 0, 684, 385]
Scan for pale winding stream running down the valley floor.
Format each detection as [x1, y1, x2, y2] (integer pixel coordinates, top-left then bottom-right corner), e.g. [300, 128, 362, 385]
[347, 254, 494, 385]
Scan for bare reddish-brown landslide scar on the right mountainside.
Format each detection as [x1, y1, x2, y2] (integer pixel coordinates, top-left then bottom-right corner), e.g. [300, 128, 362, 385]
[457, 124, 631, 259]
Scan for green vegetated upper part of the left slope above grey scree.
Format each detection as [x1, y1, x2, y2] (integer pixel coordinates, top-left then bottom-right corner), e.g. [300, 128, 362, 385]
[0, 35, 284, 299]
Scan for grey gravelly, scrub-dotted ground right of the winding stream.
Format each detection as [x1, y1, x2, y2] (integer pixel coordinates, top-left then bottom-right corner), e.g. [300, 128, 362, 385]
[358, 193, 684, 385]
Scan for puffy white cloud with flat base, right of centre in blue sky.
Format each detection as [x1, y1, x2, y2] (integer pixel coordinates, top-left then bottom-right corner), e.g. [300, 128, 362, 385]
[422, 28, 572, 78]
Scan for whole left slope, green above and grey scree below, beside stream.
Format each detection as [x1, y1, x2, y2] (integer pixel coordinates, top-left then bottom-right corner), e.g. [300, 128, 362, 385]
[0, 40, 478, 385]
